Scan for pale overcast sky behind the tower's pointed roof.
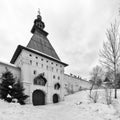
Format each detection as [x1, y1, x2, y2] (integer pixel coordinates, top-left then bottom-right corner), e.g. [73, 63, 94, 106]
[0, 0, 120, 78]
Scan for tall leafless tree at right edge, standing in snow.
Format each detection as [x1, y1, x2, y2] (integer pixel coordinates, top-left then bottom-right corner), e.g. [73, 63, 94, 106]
[100, 21, 120, 98]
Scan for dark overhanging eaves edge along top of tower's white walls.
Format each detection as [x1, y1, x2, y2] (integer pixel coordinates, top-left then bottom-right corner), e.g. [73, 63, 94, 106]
[10, 45, 68, 67]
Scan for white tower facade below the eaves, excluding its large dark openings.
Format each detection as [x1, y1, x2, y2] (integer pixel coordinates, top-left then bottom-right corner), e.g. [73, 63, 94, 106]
[15, 50, 64, 103]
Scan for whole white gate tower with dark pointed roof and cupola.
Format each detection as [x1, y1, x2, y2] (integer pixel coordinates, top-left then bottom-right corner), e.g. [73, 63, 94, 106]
[11, 12, 67, 105]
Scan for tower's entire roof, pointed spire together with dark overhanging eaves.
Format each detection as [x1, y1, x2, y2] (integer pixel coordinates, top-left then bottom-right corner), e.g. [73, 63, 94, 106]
[10, 11, 68, 66]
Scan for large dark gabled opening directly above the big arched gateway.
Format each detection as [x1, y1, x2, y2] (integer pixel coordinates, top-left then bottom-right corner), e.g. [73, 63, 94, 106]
[34, 74, 47, 86]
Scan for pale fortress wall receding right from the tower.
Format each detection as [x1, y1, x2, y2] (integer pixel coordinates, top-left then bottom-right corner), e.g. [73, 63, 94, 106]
[64, 74, 91, 95]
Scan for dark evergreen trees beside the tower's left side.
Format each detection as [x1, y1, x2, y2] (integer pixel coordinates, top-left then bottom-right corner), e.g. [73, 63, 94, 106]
[0, 70, 28, 105]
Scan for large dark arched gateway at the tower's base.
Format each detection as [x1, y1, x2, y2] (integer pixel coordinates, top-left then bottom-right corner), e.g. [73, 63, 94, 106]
[32, 90, 45, 105]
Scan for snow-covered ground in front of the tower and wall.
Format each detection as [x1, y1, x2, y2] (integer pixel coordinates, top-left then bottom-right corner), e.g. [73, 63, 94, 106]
[0, 91, 120, 120]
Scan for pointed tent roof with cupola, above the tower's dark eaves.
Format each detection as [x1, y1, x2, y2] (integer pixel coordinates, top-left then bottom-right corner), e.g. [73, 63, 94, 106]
[27, 11, 60, 60]
